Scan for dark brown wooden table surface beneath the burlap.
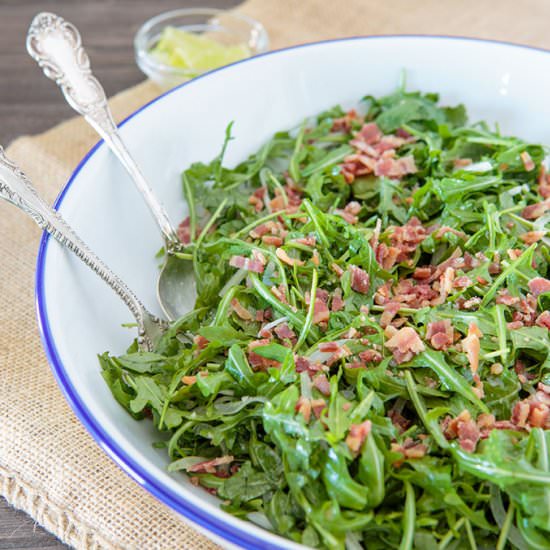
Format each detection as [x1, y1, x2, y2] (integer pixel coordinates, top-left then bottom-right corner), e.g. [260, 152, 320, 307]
[0, 0, 240, 550]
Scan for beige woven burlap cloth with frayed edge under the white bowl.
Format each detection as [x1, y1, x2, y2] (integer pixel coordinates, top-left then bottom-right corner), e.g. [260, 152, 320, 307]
[0, 0, 550, 550]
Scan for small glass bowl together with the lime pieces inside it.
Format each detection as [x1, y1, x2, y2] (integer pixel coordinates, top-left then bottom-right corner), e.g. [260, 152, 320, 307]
[134, 8, 268, 89]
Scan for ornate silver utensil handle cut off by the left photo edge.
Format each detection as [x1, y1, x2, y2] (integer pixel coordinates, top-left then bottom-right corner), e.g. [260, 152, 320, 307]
[0, 147, 163, 349]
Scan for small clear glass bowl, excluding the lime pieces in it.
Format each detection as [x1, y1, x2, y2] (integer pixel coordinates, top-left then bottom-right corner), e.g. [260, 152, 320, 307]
[134, 8, 269, 89]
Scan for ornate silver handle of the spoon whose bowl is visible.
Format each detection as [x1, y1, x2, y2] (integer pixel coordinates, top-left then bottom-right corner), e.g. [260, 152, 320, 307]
[27, 12, 180, 248]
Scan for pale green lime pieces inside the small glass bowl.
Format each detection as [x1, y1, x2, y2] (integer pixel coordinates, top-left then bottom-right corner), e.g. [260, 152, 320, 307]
[151, 27, 250, 74]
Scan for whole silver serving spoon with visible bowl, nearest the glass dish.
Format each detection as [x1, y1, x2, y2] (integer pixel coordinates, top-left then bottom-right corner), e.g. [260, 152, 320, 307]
[27, 13, 196, 320]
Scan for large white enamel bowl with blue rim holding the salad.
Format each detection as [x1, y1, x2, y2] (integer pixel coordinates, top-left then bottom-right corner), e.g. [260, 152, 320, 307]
[36, 36, 550, 549]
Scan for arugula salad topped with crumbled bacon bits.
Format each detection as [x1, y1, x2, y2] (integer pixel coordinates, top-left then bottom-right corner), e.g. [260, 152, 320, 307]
[100, 89, 550, 550]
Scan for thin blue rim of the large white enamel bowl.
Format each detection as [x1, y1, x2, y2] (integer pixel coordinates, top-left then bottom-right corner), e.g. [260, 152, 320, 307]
[35, 34, 550, 550]
